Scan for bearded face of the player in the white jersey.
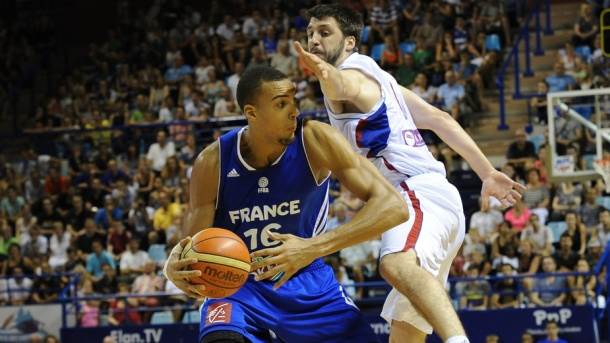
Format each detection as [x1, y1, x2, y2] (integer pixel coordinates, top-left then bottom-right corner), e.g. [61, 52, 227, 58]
[307, 17, 353, 65]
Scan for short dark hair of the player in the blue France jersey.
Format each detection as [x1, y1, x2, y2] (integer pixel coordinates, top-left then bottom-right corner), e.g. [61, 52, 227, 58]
[236, 66, 287, 111]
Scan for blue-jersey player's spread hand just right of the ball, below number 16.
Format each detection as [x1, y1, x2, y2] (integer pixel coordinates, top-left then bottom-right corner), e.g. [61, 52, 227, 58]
[250, 231, 317, 289]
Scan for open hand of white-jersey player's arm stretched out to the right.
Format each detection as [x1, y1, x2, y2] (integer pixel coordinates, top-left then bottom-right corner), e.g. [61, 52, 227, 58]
[481, 170, 526, 210]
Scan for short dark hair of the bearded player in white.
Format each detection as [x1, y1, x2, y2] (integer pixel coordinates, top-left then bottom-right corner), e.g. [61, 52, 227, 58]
[307, 4, 364, 46]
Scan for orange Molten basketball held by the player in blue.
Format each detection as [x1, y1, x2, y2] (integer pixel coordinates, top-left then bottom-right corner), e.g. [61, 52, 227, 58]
[182, 228, 250, 298]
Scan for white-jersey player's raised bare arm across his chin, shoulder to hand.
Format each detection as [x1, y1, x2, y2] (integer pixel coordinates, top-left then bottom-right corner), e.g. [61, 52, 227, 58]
[294, 42, 381, 113]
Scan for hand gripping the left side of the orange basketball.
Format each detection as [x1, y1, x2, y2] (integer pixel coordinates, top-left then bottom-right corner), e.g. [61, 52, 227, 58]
[163, 237, 205, 298]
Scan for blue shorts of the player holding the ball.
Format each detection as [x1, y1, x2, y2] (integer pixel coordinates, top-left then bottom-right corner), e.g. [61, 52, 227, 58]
[199, 260, 378, 343]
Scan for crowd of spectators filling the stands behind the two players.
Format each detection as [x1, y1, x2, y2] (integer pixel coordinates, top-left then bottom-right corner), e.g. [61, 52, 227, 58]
[0, 0, 610, 332]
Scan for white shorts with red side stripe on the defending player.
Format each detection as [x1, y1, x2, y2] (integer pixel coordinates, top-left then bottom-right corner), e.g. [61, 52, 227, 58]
[380, 173, 466, 334]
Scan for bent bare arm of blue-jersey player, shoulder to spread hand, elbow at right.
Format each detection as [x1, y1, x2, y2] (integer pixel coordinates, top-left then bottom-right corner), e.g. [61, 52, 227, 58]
[252, 121, 408, 287]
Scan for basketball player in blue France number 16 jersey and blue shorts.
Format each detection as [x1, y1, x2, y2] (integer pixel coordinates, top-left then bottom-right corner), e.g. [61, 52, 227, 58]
[164, 67, 408, 343]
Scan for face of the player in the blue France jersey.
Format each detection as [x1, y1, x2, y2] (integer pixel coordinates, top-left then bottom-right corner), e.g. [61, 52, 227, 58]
[256, 79, 299, 145]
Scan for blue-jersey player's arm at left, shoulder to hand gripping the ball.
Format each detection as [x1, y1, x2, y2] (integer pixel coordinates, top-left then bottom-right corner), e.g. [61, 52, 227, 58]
[163, 142, 219, 298]
